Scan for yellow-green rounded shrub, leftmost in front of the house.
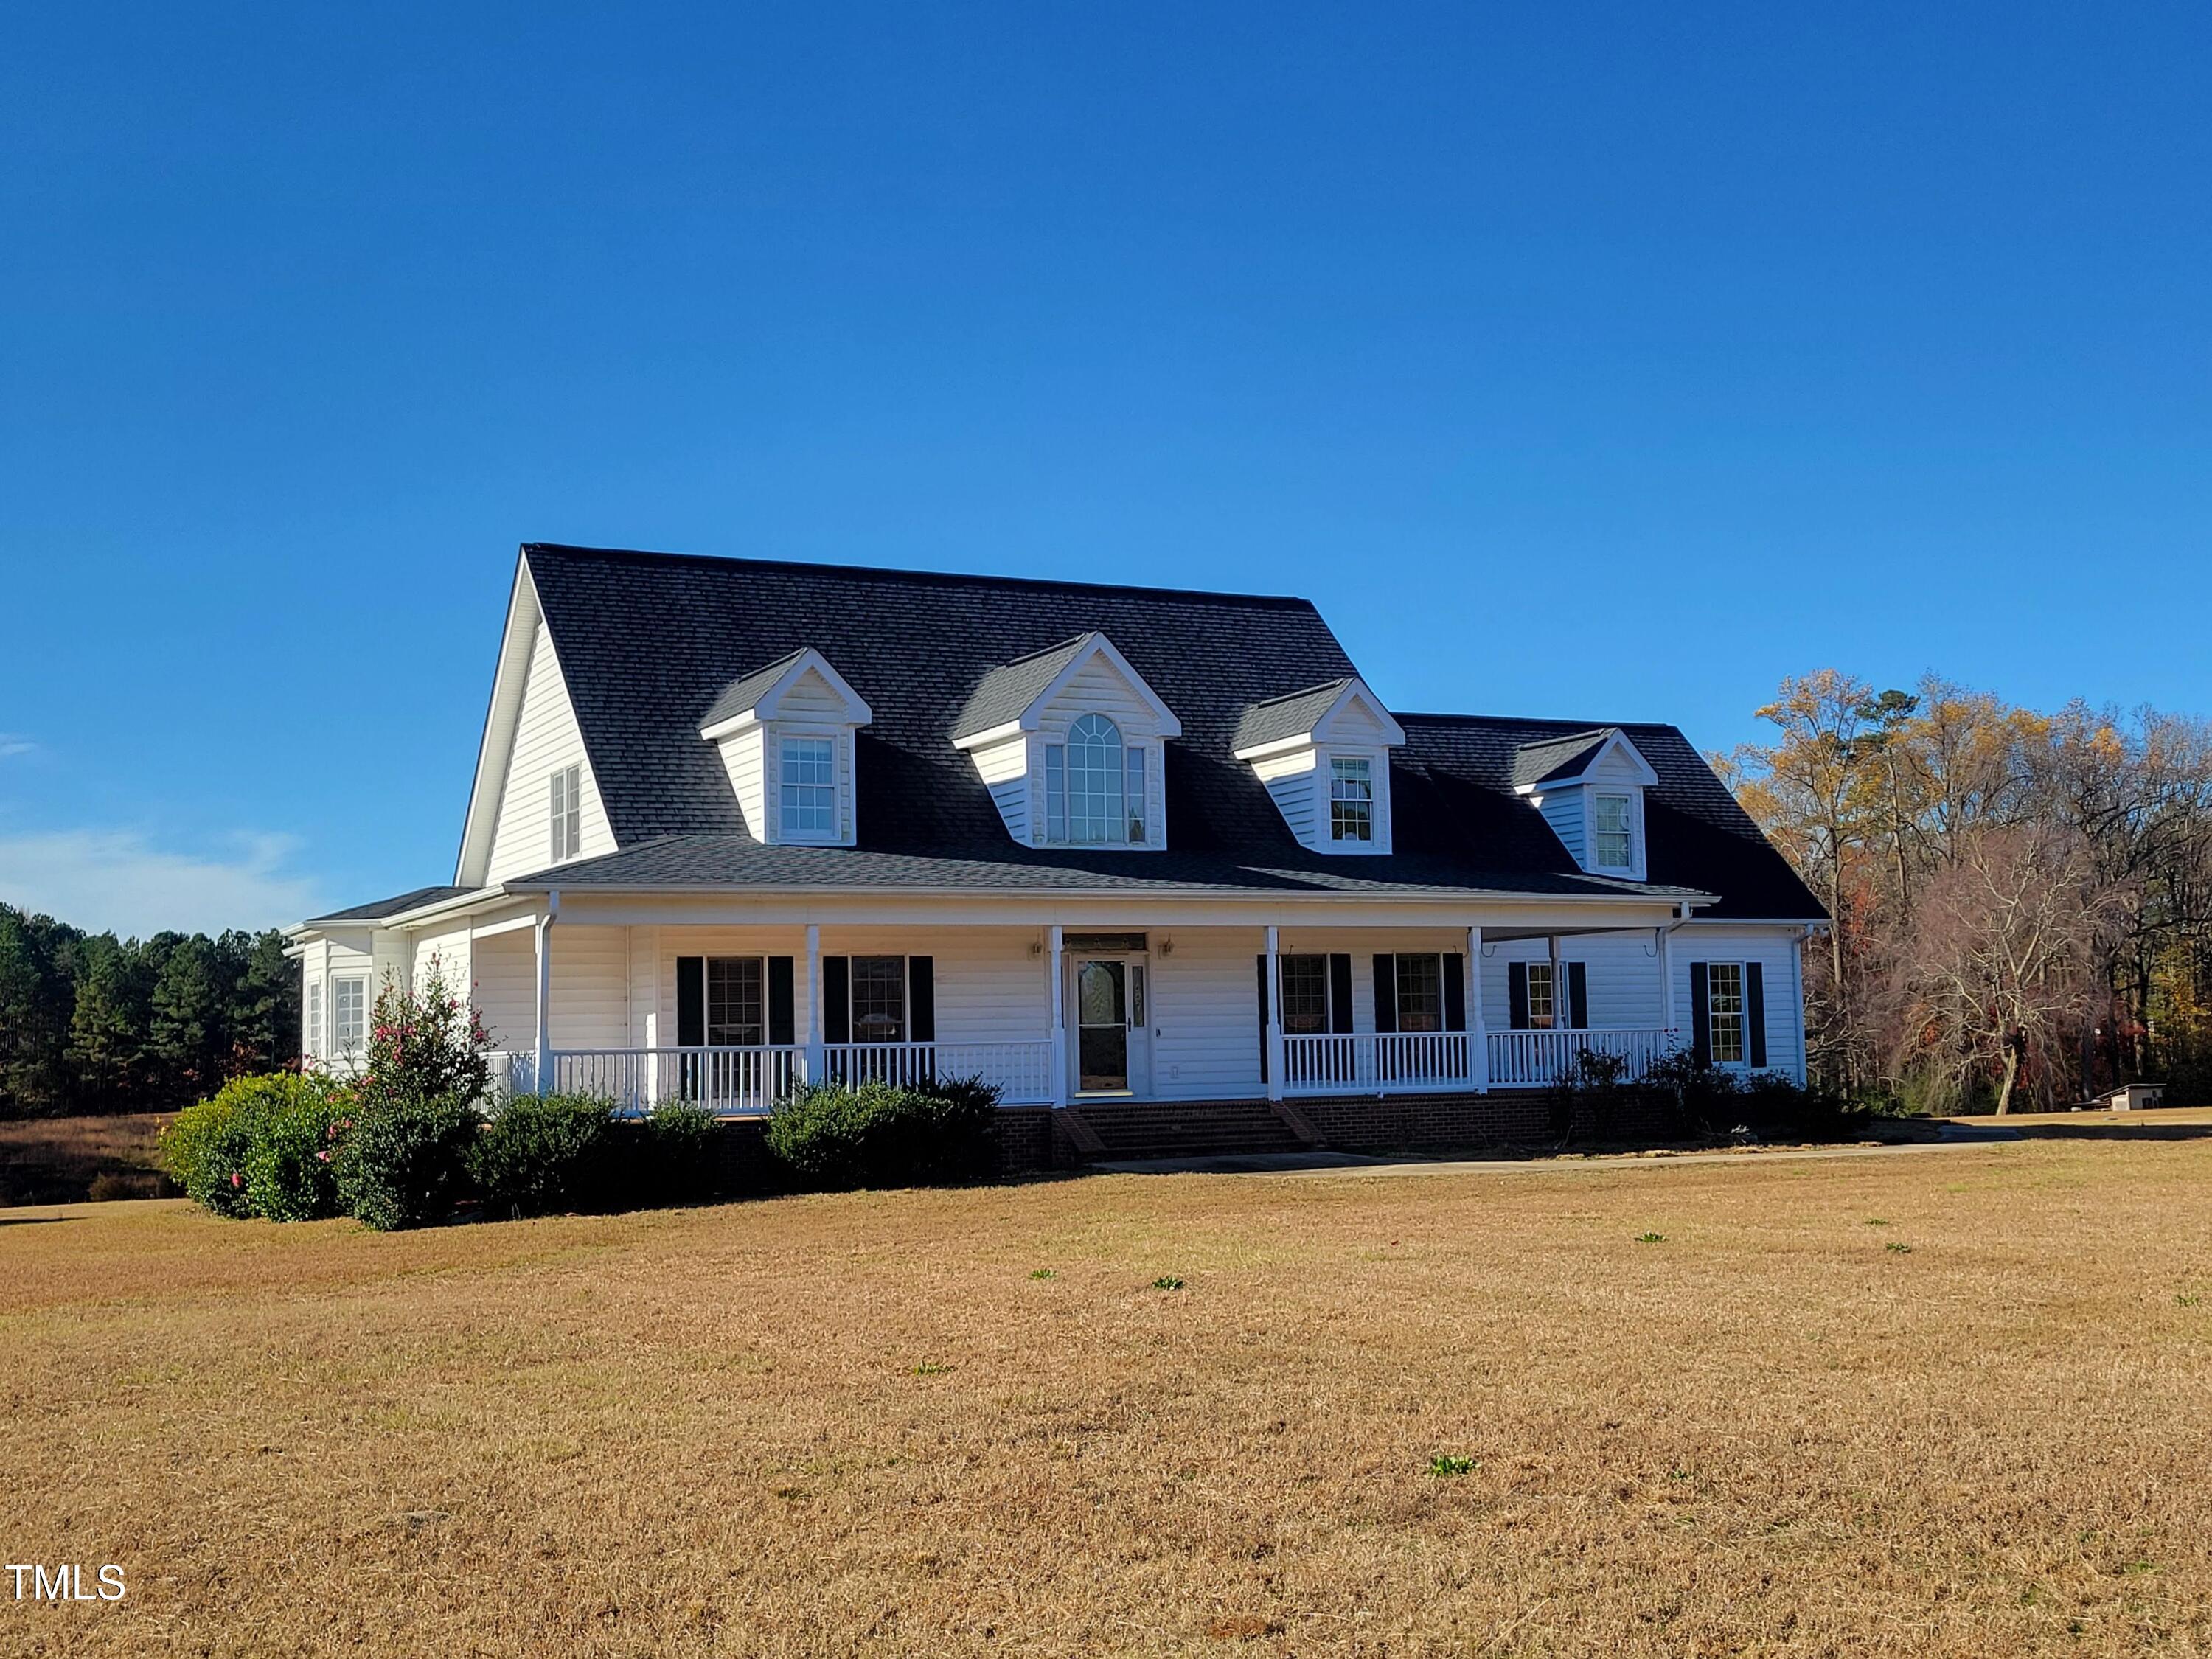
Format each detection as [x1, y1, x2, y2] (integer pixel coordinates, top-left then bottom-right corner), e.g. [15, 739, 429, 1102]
[161, 1071, 352, 1221]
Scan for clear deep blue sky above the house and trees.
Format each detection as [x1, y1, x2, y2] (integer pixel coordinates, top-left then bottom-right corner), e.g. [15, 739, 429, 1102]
[0, 0, 2212, 931]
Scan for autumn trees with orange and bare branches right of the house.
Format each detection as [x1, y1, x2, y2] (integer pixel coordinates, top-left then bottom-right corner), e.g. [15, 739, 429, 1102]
[1717, 668, 2212, 1110]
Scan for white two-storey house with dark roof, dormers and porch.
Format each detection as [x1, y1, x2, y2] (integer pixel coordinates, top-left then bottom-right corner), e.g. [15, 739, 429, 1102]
[292, 544, 1823, 1144]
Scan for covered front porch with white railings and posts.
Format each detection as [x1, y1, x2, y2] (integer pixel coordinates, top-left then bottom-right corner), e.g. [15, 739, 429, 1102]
[471, 907, 1681, 1115]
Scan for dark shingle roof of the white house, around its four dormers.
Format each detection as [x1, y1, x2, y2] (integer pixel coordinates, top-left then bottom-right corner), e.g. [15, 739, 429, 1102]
[515, 555, 1820, 918]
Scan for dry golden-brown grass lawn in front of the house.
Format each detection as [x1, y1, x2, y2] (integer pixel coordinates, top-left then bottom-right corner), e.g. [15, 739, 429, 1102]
[0, 1139, 2212, 1659]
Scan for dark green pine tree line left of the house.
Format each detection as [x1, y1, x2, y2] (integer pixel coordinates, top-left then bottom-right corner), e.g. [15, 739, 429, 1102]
[0, 905, 299, 1117]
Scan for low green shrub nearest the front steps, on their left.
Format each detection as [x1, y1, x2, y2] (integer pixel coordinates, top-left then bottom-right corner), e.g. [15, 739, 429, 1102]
[768, 1077, 998, 1188]
